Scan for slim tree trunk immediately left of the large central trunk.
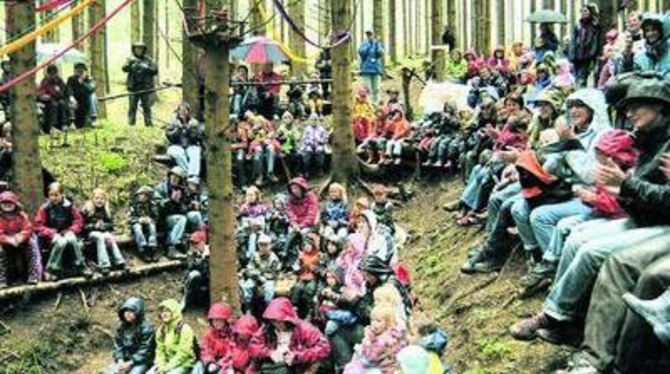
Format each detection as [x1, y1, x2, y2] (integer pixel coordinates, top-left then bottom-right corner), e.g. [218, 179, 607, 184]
[181, 0, 198, 114]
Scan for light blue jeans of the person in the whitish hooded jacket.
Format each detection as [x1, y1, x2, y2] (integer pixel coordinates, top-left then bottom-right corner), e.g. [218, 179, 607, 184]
[530, 199, 591, 252]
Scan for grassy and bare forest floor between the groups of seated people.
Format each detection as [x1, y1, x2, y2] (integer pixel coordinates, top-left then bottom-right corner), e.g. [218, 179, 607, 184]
[0, 71, 569, 374]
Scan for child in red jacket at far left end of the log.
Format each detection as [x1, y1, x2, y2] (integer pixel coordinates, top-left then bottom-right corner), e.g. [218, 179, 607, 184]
[0, 191, 42, 289]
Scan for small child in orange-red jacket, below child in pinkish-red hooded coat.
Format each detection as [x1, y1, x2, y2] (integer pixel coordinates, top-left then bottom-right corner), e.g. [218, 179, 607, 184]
[291, 234, 319, 318]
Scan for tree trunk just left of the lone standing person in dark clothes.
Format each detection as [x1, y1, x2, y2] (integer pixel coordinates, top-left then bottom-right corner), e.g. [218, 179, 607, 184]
[88, 0, 107, 119]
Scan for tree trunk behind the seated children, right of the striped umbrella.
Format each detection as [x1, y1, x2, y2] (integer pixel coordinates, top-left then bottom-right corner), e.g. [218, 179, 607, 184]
[331, 0, 359, 182]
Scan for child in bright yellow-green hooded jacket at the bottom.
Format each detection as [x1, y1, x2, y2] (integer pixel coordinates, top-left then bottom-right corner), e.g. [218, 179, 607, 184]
[149, 299, 196, 374]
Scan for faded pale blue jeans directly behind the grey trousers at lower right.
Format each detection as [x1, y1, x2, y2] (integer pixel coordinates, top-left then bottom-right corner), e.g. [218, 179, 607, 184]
[544, 219, 668, 321]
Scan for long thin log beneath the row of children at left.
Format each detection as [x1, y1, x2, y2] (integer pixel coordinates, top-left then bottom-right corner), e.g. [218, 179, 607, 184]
[0, 260, 184, 301]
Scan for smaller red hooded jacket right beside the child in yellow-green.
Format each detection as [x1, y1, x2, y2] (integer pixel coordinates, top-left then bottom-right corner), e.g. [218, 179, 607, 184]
[200, 303, 234, 369]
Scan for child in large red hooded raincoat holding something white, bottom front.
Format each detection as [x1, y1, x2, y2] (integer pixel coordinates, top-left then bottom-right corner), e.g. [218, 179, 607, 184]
[249, 297, 331, 373]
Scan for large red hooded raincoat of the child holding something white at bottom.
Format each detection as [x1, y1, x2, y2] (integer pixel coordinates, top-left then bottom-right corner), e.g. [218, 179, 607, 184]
[250, 297, 330, 367]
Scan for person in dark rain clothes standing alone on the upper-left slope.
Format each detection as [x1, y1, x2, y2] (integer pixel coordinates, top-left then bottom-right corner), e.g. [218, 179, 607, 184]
[122, 43, 158, 127]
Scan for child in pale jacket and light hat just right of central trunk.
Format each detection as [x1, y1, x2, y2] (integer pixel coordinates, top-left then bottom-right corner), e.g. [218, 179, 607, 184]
[240, 234, 281, 310]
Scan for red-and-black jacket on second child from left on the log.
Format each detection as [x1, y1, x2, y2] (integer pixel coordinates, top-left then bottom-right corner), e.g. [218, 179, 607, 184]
[35, 198, 84, 240]
